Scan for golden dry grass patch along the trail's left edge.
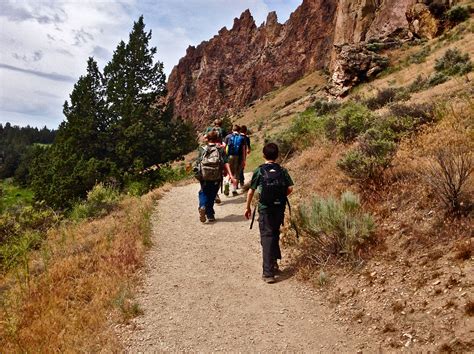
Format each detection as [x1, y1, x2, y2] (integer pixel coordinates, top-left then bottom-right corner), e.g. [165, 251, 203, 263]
[0, 185, 168, 352]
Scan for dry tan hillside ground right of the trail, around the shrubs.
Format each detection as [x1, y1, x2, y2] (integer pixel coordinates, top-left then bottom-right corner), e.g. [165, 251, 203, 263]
[222, 14, 474, 351]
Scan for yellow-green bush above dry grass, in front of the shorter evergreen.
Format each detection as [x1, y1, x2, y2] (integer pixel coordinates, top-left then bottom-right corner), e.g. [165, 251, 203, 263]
[70, 183, 120, 220]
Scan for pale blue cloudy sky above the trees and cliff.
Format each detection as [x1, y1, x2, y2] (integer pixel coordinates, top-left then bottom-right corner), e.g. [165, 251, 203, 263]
[0, 0, 302, 129]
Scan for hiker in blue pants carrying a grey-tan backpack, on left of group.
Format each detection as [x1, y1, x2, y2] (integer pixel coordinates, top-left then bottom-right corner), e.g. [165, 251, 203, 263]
[194, 131, 236, 223]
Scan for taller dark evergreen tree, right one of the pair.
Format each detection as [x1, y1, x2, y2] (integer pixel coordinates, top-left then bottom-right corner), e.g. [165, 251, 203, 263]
[104, 16, 177, 173]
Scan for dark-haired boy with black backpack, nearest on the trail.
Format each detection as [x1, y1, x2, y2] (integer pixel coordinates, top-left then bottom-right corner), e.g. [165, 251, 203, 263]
[245, 143, 293, 283]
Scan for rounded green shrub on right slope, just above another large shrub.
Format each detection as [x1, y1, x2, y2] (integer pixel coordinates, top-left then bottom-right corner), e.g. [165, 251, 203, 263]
[325, 102, 373, 143]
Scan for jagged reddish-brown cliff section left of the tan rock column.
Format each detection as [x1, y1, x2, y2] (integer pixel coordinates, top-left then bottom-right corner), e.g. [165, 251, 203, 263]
[168, 0, 336, 125]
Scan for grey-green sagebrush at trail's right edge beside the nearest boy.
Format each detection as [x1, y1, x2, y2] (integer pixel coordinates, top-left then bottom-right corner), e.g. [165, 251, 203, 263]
[298, 192, 375, 264]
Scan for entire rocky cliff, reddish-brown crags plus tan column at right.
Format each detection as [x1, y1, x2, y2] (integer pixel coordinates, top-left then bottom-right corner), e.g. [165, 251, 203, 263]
[168, 0, 452, 126]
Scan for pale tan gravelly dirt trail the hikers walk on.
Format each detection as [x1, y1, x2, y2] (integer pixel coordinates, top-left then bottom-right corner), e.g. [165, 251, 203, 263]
[116, 184, 364, 352]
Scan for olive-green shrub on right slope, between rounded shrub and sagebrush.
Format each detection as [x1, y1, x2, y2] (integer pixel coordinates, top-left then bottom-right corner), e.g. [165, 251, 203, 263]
[337, 128, 396, 183]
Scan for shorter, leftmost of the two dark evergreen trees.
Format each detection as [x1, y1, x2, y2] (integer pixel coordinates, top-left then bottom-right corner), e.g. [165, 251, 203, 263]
[28, 58, 115, 208]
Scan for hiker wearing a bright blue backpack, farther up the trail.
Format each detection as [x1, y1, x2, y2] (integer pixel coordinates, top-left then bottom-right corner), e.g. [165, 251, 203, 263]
[224, 125, 247, 196]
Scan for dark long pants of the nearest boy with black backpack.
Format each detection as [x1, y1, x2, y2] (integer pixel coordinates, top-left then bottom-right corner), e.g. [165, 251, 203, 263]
[258, 208, 285, 277]
